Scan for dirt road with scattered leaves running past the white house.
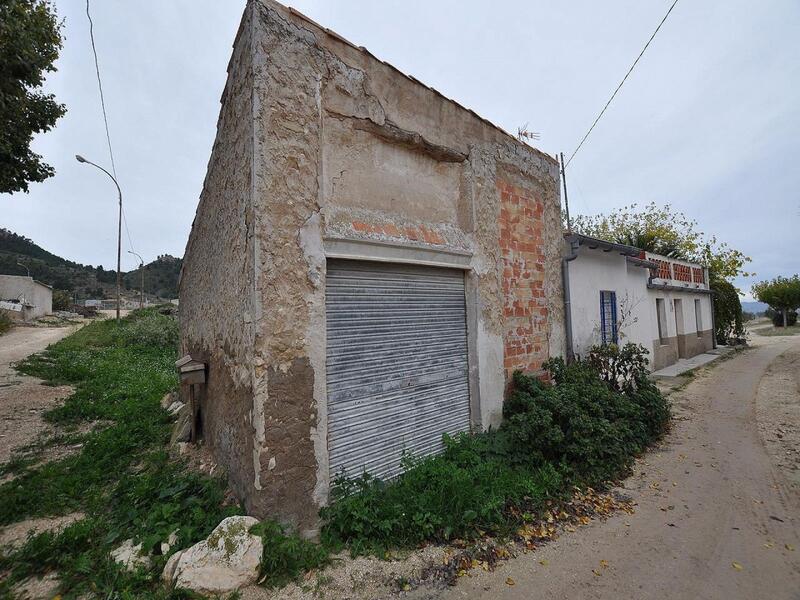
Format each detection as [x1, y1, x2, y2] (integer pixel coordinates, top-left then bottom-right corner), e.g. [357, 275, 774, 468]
[432, 338, 800, 600]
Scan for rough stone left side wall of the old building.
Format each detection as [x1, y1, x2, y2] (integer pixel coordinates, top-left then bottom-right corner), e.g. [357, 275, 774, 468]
[179, 11, 263, 510]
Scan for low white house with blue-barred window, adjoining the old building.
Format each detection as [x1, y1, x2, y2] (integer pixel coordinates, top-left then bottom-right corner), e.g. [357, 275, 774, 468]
[562, 234, 715, 370]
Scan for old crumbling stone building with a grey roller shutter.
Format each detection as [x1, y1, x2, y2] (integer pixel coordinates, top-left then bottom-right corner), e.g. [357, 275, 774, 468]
[180, 0, 564, 535]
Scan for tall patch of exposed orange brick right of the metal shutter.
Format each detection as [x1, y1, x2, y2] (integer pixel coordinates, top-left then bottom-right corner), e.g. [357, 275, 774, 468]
[497, 180, 548, 377]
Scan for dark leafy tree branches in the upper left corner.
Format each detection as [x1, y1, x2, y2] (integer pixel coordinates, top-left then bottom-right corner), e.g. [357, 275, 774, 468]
[0, 0, 66, 193]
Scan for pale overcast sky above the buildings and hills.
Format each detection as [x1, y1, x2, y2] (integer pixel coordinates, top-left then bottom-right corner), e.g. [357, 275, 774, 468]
[0, 0, 800, 299]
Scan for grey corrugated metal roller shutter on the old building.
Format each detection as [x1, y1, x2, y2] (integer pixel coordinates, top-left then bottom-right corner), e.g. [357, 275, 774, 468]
[325, 259, 470, 478]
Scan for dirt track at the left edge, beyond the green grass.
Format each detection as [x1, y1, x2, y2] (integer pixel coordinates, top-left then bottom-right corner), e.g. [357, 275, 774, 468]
[0, 327, 76, 464]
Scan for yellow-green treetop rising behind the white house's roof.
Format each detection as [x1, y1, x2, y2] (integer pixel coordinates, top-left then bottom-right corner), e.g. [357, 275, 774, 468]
[572, 202, 751, 279]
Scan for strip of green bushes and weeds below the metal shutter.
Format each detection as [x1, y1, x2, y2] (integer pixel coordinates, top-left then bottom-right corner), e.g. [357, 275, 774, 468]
[320, 352, 669, 553]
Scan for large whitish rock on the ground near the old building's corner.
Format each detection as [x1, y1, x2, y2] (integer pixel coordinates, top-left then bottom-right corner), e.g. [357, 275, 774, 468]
[163, 517, 264, 594]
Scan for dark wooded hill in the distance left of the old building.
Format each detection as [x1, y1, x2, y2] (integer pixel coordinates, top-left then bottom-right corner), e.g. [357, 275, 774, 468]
[0, 228, 181, 300]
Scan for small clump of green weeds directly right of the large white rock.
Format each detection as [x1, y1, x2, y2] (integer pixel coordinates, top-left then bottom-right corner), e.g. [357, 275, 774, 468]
[250, 521, 330, 587]
